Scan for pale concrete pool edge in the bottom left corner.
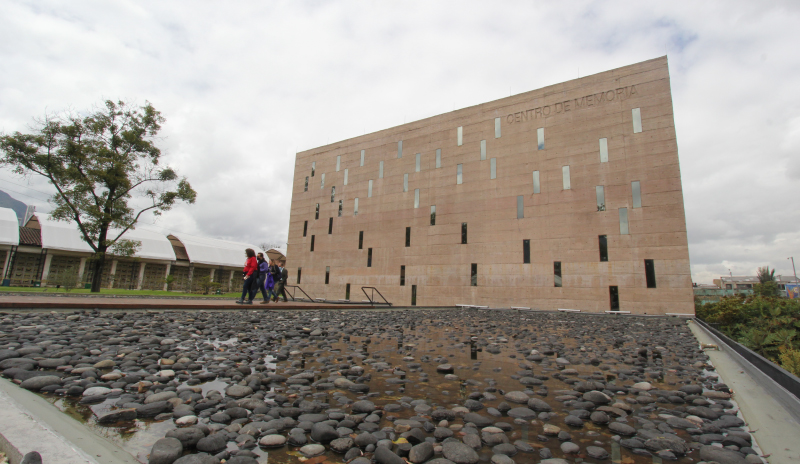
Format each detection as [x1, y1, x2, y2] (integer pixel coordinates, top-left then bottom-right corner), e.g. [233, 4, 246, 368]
[0, 379, 139, 464]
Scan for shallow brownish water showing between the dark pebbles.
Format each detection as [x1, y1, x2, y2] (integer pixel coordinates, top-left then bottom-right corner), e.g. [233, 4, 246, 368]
[29, 312, 715, 464]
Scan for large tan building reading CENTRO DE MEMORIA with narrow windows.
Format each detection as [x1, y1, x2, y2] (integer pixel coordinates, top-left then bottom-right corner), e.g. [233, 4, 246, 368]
[287, 57, 694, 314]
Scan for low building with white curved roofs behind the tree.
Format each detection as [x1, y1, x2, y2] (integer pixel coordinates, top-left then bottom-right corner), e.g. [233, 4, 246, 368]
[0, 208, 270, 291]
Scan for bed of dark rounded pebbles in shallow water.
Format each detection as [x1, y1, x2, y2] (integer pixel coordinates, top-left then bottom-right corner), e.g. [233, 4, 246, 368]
[0, 310, 764, 464]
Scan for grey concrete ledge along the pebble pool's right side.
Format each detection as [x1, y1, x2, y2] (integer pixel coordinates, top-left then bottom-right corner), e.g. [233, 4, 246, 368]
[688, 321, 800, 464]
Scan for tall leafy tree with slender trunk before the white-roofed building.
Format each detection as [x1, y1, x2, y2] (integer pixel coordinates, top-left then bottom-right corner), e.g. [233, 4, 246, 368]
[0, 100, 197, 291]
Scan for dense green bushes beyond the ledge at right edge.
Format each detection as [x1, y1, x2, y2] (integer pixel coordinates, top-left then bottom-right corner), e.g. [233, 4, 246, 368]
[696, 294, 800, 370]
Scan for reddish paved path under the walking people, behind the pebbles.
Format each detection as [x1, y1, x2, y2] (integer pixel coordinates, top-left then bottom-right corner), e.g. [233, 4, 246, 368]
[0, 295, 372, 310]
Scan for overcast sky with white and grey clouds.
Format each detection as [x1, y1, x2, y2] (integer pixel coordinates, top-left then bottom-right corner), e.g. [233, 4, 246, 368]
[0, 0, 800, 283]
